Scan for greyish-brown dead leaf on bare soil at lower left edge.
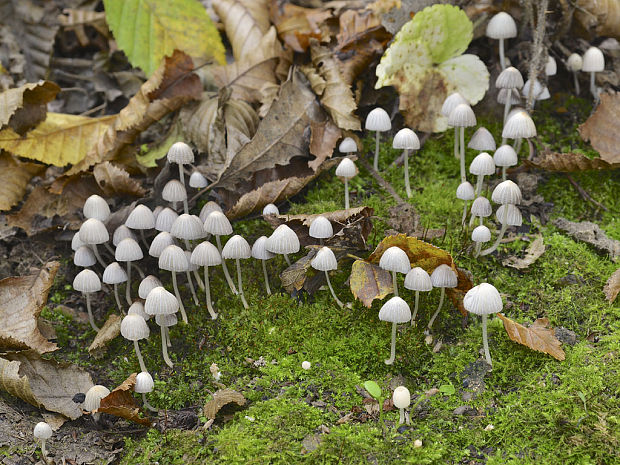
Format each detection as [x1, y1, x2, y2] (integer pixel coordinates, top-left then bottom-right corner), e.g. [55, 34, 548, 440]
[0, 351, 93, 420]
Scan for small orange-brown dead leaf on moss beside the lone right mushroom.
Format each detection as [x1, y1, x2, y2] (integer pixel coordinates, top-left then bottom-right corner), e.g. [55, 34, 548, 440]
[497, 313, 566, 360]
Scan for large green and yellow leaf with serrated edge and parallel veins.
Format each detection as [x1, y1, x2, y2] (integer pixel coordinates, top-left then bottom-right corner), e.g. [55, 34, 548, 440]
[103, 0, 225, 76]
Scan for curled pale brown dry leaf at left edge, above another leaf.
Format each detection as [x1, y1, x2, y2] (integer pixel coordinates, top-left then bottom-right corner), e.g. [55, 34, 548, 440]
[0, 262, 60, 354]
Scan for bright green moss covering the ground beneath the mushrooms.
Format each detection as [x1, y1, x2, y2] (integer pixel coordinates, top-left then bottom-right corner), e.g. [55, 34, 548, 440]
[46, 95, 620, 465]
